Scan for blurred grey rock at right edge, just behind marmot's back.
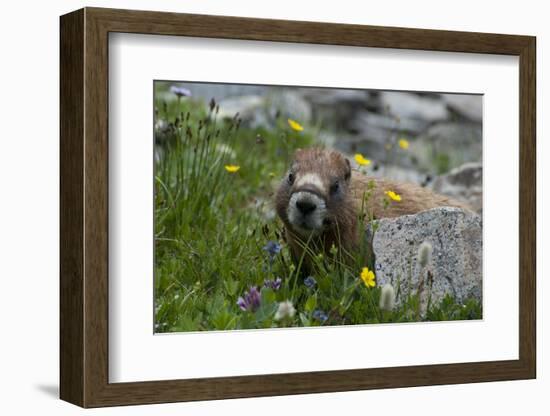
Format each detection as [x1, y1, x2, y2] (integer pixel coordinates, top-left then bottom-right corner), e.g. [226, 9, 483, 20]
[430, 163, 483, 214]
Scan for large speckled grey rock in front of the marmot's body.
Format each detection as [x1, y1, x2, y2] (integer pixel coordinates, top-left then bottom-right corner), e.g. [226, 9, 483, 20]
[371, 207, 482, 314]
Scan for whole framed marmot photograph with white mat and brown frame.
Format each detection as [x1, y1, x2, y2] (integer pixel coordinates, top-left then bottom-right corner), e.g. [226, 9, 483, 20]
[60, 8, 536, 407]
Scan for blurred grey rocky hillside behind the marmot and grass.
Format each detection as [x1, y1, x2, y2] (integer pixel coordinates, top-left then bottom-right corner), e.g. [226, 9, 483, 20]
[160, 83, 482, 213]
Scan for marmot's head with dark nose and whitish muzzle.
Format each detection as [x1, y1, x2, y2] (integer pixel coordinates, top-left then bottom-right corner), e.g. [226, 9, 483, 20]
[276, 148, 351, 237]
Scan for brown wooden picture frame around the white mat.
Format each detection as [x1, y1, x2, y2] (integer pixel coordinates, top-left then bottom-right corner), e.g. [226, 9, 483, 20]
[60, 8, 536, 407]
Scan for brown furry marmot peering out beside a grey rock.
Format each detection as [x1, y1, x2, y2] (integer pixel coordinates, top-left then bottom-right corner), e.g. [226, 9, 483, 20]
[275, 148, 467, 260]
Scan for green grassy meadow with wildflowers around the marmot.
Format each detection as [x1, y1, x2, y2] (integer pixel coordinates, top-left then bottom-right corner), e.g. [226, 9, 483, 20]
[154, 89, 481, 332]
